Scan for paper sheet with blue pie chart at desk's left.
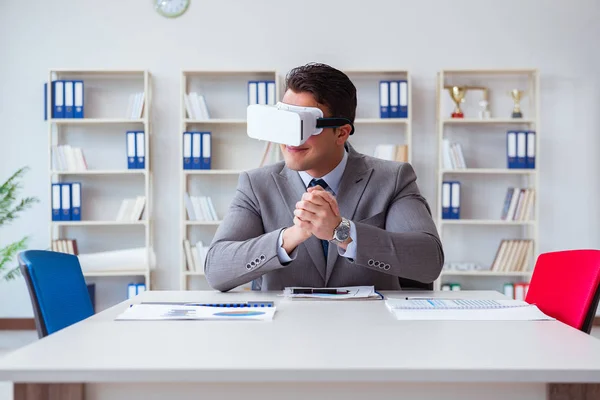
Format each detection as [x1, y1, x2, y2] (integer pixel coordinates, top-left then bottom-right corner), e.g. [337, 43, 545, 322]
[116, 304, 276, 321]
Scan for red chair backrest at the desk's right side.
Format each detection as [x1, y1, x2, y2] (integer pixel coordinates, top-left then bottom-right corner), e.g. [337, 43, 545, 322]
[525, 250, 600, 333]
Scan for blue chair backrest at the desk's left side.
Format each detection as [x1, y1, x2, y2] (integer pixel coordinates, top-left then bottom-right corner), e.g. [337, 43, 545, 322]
[19, 250, 94, 337]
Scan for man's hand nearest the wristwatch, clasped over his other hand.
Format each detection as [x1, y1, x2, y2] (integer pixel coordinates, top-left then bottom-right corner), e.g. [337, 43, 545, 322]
[294, 186, 342, 240]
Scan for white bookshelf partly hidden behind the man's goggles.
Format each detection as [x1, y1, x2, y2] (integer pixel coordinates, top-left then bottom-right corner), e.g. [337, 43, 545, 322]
[178, 70, 281, 290]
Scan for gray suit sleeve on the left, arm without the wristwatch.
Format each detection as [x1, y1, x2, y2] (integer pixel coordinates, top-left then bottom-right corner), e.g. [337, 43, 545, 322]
[204, 172, 297, 292]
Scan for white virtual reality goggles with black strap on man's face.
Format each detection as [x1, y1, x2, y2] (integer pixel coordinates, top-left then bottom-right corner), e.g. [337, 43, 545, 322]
[247, 102, 354, 146]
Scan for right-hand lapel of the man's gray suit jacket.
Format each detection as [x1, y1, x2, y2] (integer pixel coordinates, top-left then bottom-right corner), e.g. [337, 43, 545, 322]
[325, 144, 373, 284]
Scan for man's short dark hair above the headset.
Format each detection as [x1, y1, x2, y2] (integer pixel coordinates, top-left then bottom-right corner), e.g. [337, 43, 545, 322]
[285, 63, 356, 123]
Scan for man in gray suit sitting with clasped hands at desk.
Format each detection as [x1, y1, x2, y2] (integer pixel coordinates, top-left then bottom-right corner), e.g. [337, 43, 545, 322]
[205, 64, 444, 291]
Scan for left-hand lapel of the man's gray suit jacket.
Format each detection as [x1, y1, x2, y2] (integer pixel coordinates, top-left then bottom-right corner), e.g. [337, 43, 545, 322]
[272, 167, 326, 280]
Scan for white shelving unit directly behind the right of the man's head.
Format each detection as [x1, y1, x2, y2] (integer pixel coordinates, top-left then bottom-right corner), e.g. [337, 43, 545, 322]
[344, 69, 413, 162]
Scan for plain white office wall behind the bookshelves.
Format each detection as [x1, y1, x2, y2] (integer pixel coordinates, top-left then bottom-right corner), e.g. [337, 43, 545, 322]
[0, 0, 600, 317]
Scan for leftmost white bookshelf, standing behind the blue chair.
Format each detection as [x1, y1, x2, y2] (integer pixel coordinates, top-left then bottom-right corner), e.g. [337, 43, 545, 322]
[45, 69, 154, 310]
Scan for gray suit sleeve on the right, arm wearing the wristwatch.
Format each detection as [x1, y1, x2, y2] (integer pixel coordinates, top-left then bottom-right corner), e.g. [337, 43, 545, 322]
[354, 163, 444, 283]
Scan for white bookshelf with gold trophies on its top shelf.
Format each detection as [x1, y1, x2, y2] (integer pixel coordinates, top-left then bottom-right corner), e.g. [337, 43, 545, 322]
[435, 69, 542, 292]
